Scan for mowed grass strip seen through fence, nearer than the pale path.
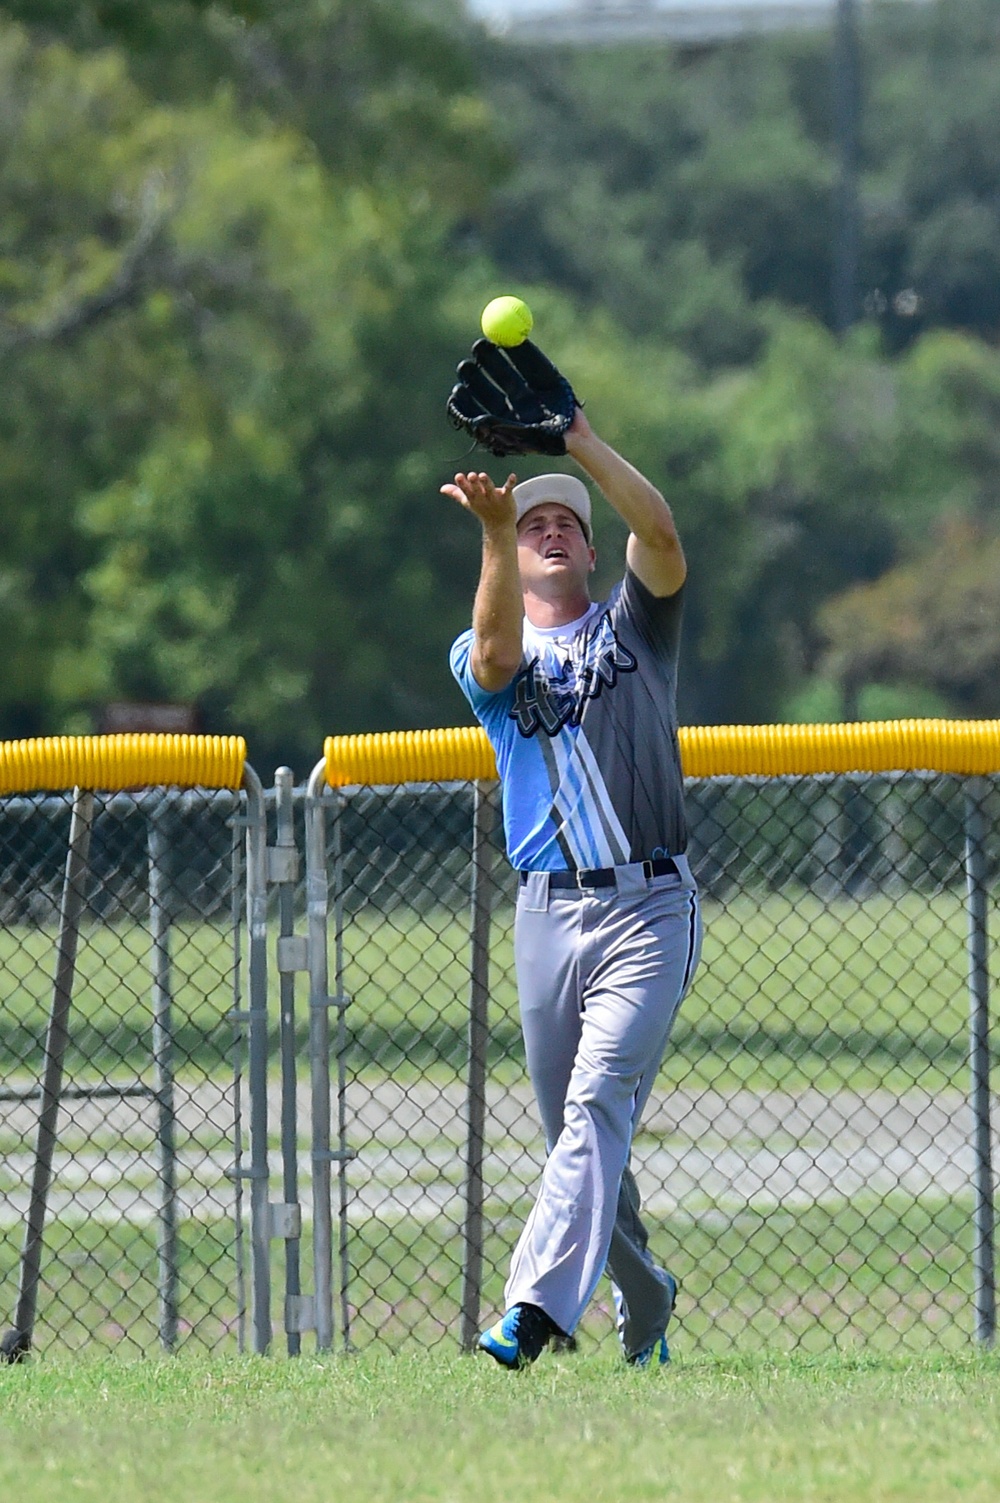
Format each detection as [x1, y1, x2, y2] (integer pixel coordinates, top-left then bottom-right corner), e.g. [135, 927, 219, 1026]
[0, 1196, 973, 1360]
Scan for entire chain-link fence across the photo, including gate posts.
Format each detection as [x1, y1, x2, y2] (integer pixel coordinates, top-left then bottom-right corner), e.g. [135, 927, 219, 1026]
[0, 730, 1000, 1354]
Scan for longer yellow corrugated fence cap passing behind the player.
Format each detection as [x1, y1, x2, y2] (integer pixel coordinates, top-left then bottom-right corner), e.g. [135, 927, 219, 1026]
[323, 720, 1000, 788]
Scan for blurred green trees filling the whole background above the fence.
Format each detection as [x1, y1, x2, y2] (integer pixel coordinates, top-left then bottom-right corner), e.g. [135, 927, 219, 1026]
[0, 0, 1000, 773]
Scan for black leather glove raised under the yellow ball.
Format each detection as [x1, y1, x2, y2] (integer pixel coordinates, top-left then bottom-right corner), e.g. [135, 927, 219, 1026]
[448, 340, 582, 455]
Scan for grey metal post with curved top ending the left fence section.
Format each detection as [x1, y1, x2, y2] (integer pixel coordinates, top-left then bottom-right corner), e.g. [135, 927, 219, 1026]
[244, 767, 271, 1354]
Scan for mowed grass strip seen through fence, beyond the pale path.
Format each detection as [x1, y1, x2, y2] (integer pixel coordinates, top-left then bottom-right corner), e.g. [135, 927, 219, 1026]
[0, 890, 1000, 1093]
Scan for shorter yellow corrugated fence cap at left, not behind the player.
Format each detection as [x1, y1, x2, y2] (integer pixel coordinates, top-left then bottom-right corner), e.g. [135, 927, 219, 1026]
[0, 733, 247, 797]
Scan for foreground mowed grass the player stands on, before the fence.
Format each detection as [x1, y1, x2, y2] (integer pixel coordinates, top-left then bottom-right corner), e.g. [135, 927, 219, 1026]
[0, 1354, 1000, 1503]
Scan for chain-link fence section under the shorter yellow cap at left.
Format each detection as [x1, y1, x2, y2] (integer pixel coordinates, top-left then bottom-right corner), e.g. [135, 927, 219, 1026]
[0, 739, 269, 1356]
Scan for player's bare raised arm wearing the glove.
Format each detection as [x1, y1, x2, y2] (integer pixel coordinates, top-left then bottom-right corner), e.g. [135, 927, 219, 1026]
[565, 407, 687, 597]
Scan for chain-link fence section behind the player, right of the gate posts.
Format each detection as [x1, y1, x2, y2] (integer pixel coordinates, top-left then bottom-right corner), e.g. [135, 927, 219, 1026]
[303, 774, 1000, 1353]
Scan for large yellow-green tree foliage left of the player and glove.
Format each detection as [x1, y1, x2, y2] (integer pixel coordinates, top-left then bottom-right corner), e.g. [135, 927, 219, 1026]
[0, 8, 502, 770]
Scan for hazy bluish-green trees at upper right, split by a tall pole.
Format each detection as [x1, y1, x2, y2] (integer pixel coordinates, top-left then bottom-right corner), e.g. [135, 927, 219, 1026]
[484, 0, 1000, 353]
